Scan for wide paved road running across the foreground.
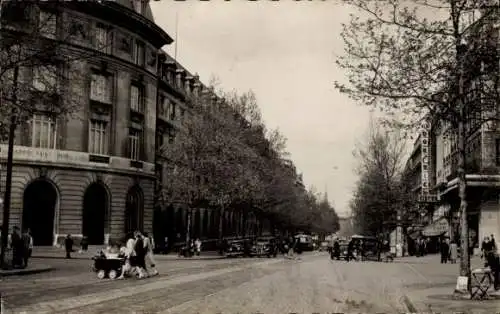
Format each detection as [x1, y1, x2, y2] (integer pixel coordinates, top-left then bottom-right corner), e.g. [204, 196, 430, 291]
[1, 254, 499, 314]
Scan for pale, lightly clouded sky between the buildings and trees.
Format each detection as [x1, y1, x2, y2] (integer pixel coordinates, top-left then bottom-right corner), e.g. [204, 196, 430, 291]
[151, 0, 370, 215]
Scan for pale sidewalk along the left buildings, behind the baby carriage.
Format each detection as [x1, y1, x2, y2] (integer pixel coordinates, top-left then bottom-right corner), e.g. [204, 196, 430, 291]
[32, 245, 224, 261]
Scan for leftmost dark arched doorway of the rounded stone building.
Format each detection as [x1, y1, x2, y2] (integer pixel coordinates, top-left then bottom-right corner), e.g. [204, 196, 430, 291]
[22, 180, 58, 245]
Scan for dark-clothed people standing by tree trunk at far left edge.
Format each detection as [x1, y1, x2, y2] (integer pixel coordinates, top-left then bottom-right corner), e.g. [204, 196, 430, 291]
[0, 226, 33, 268]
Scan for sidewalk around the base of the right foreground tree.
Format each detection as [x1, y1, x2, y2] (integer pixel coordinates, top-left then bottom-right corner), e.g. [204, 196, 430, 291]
[395, 255, 500, 314]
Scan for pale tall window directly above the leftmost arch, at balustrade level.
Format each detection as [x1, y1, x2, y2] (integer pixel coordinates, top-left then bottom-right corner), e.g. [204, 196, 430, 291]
[31, 114, 57, 149]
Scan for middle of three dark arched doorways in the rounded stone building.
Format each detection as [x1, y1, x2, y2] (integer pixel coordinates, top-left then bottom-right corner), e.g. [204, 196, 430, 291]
[82, 183, 109, 245]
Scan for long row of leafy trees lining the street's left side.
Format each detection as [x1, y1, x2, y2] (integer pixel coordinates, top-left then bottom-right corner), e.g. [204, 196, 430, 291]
[158, 84, 338, 247]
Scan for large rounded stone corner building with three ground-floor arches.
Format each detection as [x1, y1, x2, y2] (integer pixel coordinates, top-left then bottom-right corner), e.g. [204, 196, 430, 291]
[0, 0, 172, 245]
